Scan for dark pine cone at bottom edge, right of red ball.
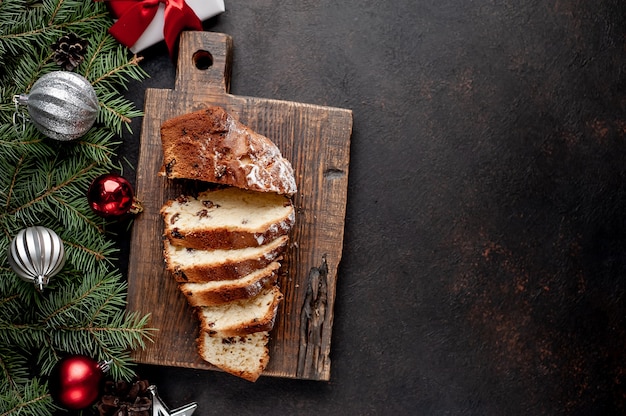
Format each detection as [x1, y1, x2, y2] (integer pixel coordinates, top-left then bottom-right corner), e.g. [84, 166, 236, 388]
[96, 379, 152, 416]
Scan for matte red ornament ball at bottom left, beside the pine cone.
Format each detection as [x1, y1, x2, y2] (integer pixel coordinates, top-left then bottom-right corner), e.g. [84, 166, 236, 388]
[49, 355, 104, 410]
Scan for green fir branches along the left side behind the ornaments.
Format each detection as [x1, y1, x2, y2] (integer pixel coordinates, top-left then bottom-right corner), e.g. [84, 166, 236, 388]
[0, 0, 151, 416]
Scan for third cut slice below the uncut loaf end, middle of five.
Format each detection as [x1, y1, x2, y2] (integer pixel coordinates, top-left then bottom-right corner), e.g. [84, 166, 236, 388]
[178, 262, 280, 307]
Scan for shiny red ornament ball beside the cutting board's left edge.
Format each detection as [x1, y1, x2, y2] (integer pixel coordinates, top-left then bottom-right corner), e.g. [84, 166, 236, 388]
[87, 173, 135, 217]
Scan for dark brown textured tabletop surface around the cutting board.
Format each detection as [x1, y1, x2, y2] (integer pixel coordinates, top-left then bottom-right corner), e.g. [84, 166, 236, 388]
[112, 0, 626, 415]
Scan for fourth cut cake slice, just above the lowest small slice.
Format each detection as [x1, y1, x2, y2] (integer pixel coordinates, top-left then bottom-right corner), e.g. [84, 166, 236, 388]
[196, 286, 283, 337]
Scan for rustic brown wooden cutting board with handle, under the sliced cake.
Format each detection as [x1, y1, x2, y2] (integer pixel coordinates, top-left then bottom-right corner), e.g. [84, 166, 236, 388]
[128, 32, 352, 380]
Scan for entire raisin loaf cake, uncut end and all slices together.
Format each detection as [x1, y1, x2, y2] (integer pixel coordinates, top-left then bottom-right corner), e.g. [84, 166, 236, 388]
[159, 107, 297, 381]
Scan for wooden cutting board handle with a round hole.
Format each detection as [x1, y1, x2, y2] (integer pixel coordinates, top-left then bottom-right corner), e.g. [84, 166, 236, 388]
[174, 31, 233, 93]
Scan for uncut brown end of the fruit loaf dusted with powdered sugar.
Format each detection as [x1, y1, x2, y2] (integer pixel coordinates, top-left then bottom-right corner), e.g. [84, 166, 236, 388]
[159, 106, 296, 195]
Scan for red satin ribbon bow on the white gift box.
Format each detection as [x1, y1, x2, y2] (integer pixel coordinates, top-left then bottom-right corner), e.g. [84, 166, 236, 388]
[102, 0, 202, 57]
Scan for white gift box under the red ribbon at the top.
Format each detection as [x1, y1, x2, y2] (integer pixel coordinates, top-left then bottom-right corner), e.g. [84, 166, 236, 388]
[105, 0, 225, 53]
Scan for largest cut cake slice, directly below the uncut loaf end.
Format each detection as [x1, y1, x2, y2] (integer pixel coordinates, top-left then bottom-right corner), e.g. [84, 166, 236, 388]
[161, 187, 295, 250]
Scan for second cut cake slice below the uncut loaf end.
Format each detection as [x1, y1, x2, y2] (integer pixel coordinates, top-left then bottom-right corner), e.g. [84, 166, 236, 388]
[163, 235, 289, 283]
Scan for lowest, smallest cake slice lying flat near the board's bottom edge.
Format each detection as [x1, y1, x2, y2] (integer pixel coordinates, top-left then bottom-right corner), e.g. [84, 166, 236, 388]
[197, 331, 270, 382]
